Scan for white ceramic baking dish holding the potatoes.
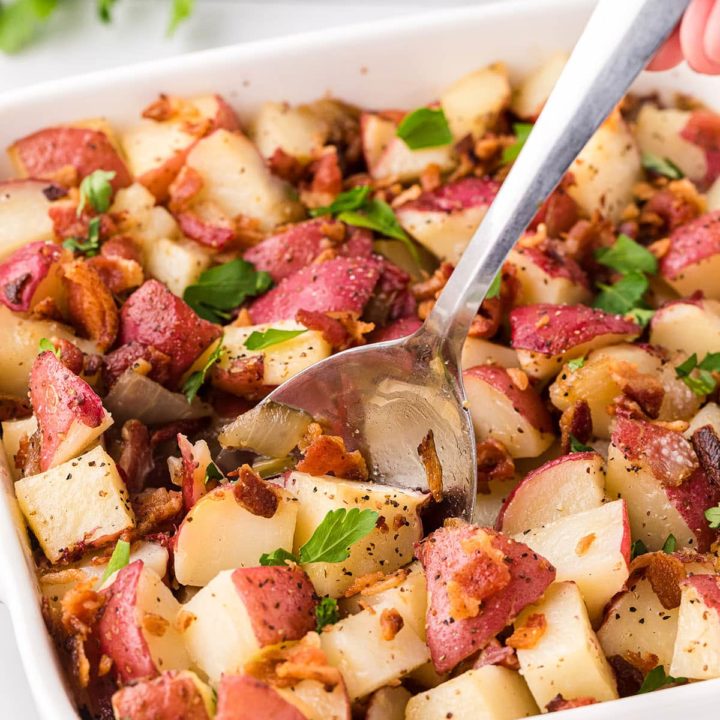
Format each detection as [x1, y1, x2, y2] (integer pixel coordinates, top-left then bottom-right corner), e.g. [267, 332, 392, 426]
[0, 0, 720, 720]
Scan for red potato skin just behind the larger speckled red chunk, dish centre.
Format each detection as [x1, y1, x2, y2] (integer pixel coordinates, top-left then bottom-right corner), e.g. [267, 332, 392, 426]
[243, 217, 372, 283]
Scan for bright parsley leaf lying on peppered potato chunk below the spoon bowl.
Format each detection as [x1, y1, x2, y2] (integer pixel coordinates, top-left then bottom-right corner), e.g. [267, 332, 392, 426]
[300, 508, 378, 563]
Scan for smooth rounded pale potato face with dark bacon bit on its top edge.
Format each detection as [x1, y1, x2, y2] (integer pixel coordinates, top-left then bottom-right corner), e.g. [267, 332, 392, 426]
[174, 485, 298, 586]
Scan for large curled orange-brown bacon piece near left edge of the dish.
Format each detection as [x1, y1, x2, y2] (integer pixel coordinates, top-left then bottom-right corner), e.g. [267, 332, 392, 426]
[63, 260, 120, 352]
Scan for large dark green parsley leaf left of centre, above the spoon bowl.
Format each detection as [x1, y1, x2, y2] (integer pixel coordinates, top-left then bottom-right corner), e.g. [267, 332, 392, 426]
[183, 258, 272, 324]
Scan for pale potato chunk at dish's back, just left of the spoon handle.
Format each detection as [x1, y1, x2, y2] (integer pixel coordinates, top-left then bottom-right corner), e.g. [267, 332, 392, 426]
[440, 63, 511, 140]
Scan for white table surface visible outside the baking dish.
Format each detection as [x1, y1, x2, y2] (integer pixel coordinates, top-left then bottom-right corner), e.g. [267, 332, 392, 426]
[0, 0, 482, 720]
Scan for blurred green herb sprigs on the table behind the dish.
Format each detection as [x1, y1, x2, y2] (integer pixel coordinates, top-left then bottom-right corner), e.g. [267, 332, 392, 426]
[0, 0, 195, 53]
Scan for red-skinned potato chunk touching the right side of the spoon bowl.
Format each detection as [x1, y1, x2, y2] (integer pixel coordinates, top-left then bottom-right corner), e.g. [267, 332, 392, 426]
[463, 365, 555, 457]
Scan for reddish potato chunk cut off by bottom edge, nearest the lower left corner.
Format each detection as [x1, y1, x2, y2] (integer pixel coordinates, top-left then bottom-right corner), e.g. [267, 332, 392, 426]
[112, 670, 212, 720]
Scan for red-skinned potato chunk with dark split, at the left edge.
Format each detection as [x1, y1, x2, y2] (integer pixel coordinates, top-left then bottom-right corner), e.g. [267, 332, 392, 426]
[0, 242, 66, 312]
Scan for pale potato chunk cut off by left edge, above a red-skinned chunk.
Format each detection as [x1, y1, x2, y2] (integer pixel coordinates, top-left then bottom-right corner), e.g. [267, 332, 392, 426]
[0, 180, 53, 258]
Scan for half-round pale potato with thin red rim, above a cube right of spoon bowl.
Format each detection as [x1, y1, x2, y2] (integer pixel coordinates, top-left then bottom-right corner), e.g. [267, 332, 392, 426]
[501, 453, 605, 535]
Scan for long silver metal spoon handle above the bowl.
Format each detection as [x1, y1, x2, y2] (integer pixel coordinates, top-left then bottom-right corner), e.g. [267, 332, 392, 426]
[420, 0, 689, 362]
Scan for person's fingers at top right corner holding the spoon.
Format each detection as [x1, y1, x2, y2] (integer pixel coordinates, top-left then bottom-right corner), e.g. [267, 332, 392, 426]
[647, 0, 720, 75]
